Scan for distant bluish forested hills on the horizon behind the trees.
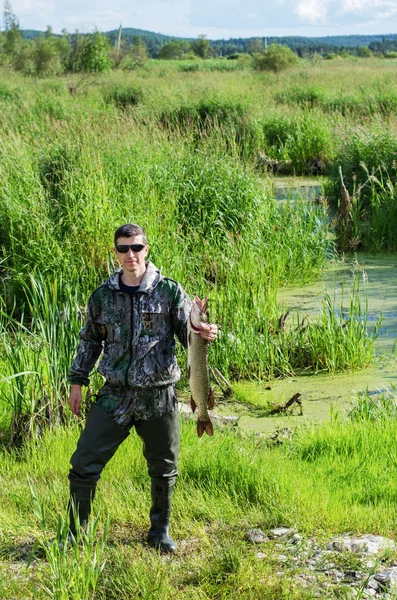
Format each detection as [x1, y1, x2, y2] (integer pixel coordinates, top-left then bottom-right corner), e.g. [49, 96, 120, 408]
[22, 27, 397, 58]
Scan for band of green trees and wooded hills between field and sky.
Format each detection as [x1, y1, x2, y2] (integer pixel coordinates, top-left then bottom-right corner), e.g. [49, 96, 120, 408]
[0, 0, 397, 76]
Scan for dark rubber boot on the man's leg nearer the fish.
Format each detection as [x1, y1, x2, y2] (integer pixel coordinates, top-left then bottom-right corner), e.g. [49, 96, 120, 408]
[147, 478, 176, 552]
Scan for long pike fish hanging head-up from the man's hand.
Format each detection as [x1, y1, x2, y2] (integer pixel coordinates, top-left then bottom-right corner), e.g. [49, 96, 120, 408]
[187, 296, 214, 437]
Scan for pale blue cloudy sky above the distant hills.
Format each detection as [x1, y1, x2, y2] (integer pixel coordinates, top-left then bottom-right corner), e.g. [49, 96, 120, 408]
[10, 0, 397, 39]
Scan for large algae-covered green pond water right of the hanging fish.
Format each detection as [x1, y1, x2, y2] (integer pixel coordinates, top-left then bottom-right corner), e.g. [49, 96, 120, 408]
[220, 254, 397, 434]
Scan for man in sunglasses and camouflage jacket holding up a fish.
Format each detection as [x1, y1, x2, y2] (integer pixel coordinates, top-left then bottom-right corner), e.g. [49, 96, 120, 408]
[69, 224, 217, 552]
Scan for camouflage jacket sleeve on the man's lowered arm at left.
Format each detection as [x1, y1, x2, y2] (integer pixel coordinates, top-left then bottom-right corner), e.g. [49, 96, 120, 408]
[68, 296, 106, 385]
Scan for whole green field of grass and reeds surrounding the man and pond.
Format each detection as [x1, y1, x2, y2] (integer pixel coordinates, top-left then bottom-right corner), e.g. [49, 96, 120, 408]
[0, 58, 397, 600]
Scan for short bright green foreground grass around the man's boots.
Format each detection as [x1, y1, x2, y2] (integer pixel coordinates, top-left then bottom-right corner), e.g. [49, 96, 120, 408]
[0, 416, 397, 600]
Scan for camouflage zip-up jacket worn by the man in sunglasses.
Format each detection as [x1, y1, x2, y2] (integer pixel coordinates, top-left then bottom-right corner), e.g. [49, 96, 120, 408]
[69, 261, 191, 389]
